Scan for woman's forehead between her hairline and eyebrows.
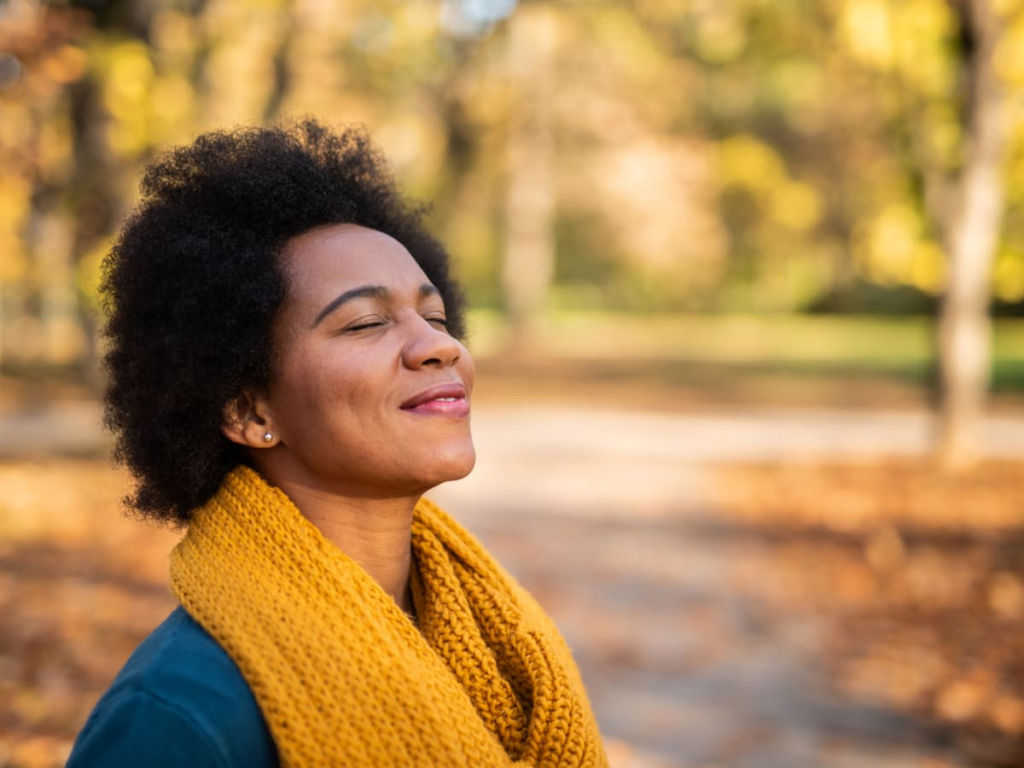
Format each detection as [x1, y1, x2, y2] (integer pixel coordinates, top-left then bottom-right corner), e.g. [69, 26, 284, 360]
[282, 224, 430, 301]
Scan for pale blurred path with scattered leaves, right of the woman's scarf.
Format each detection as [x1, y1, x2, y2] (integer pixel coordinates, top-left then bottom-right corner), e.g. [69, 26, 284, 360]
[425, 409, 1024, 768]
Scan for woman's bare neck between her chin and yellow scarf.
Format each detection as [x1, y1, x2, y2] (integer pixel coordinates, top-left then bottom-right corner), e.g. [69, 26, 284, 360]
[271, 480, 419, 613]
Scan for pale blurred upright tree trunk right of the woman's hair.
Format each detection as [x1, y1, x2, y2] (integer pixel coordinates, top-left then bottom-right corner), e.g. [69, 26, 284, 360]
[502, 5, 555, 345]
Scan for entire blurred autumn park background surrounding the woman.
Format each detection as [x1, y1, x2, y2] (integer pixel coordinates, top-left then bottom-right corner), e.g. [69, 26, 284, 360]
[0, 0, 1024, 767]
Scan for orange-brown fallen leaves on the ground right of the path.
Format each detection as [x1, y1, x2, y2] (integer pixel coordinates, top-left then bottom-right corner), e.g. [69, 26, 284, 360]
[717, 459, 1024, 766]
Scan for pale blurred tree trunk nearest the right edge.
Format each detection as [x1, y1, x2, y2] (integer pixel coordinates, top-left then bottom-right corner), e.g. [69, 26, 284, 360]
[938, 0, 1006, 469]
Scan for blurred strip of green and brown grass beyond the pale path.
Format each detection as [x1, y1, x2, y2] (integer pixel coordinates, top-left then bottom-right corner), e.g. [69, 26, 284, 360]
[0, 310, 1024, 410]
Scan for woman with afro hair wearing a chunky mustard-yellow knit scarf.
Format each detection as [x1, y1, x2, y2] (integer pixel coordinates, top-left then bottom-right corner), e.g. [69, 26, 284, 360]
[69, 122, 606, 768]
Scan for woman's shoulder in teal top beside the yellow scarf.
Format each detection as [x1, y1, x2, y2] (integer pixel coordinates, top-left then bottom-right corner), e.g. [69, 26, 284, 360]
[68, 607, 278, 768]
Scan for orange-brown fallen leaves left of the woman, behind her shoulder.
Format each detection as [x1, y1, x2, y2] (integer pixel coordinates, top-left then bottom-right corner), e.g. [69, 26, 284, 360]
[0, 460, 177, 768]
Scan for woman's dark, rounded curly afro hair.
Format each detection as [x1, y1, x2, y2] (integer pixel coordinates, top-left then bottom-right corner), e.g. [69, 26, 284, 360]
[101, 120, 464, 524]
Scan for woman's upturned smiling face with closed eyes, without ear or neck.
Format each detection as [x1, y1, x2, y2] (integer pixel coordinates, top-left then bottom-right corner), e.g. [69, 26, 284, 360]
[258, 224, 476, 498]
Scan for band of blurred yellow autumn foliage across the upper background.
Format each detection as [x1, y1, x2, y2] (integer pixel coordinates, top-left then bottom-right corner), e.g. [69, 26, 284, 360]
[0, 0, 1024, 397]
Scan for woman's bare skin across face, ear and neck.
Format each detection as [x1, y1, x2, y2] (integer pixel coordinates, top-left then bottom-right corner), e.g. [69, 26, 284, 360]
[223, 224, 476, 611]
